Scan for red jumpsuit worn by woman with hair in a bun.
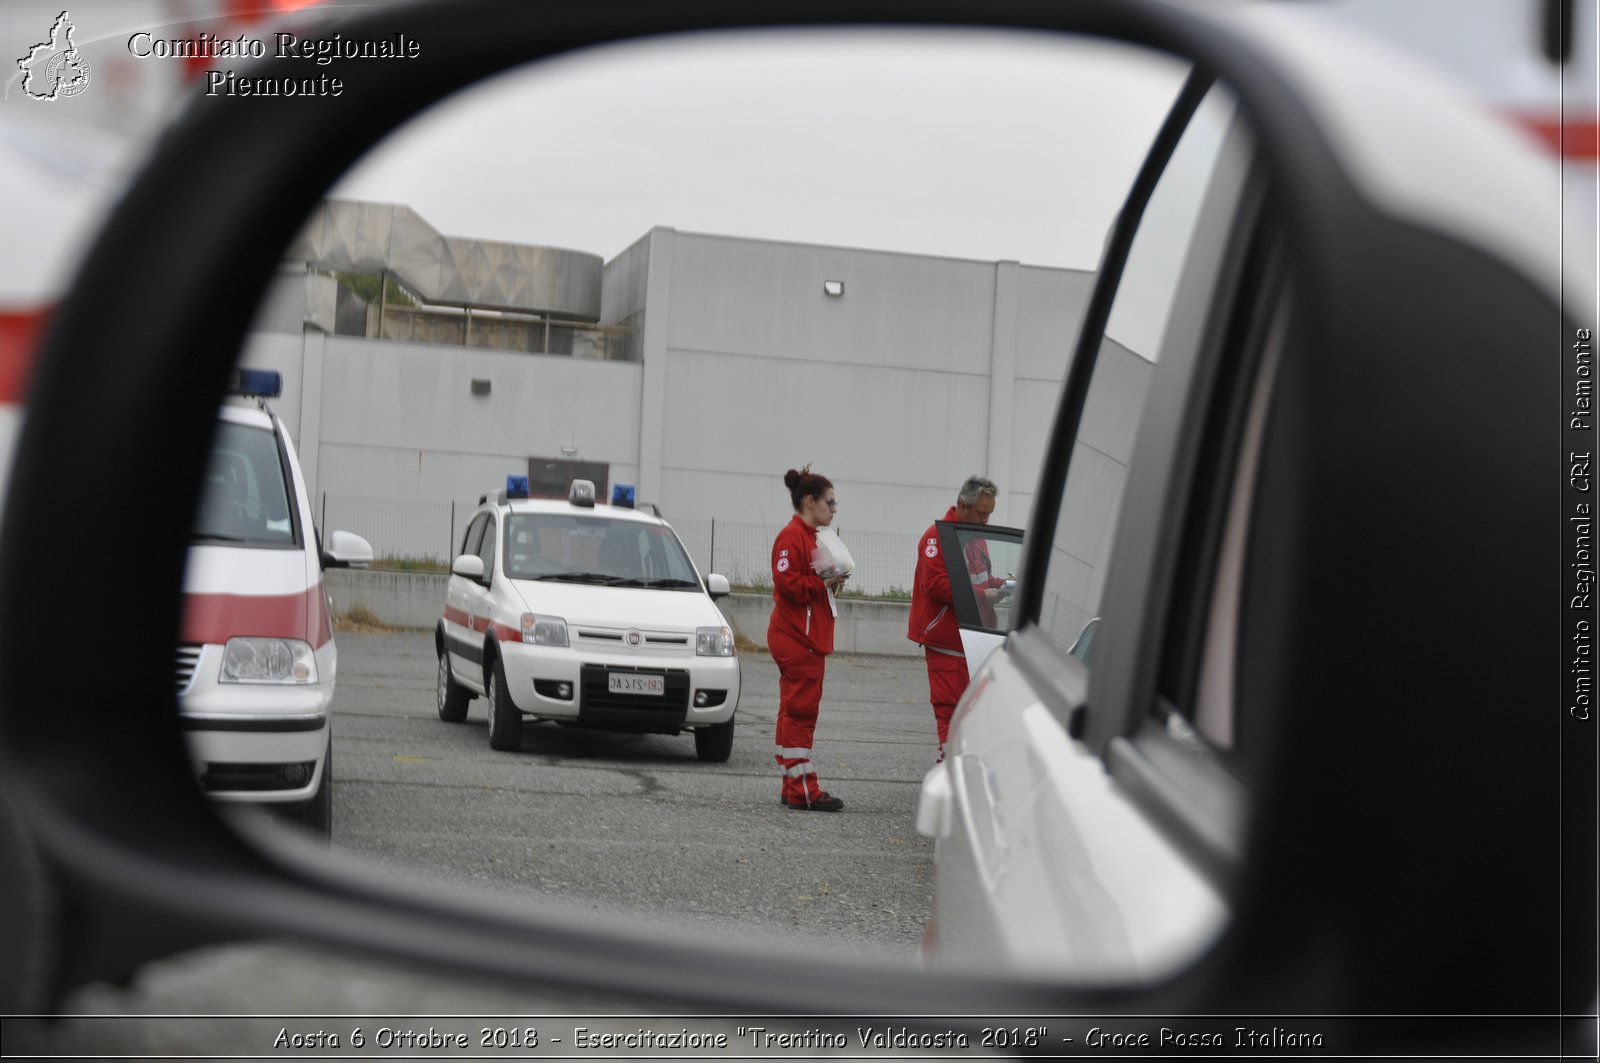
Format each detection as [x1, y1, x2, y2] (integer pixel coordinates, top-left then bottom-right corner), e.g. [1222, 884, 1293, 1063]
[766, 515, 834, 805]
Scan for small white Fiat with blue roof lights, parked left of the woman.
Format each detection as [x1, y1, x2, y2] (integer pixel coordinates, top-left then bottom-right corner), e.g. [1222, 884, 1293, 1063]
[437, 482, 739, 759]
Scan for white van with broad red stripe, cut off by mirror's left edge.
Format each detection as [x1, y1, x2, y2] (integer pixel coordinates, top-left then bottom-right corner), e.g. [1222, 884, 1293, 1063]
[178, 370, 373, 832]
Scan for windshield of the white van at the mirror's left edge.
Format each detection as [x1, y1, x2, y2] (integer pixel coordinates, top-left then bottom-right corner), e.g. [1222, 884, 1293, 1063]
[194, 421, 299, 546]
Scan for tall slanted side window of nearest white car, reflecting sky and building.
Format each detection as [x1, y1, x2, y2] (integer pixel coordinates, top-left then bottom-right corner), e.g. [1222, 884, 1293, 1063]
[1038, 88, 1234, 664]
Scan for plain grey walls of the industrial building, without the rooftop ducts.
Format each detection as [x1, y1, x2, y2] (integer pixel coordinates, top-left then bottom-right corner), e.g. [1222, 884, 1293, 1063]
[245, 227, 1100, 592]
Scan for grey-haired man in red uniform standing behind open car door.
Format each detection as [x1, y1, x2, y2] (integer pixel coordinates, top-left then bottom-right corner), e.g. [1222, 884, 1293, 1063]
[906, 475, 1005, 764]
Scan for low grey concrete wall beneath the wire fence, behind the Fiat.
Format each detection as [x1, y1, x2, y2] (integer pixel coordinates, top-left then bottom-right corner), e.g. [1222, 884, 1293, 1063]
[323, 568, 922, 656]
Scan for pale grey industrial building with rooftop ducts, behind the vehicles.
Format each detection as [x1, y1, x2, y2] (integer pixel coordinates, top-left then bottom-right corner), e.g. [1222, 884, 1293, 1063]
[243, 200, 1147, 592]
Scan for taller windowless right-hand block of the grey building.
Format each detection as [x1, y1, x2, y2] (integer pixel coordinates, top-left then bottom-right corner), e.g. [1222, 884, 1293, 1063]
[643, 229, 1091, 535]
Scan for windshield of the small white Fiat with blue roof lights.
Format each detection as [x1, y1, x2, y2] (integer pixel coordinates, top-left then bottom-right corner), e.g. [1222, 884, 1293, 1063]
[506, 514, 699, 589]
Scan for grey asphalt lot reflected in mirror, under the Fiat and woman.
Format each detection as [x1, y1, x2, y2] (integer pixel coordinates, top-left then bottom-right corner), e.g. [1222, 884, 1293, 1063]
[334, 632, 936, 957]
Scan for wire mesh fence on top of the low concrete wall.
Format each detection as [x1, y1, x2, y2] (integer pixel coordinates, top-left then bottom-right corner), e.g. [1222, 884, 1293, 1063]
[318, 493, 920, 597]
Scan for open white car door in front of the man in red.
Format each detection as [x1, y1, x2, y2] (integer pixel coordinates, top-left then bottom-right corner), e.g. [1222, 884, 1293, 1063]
[934, 520, 1022, 674]
